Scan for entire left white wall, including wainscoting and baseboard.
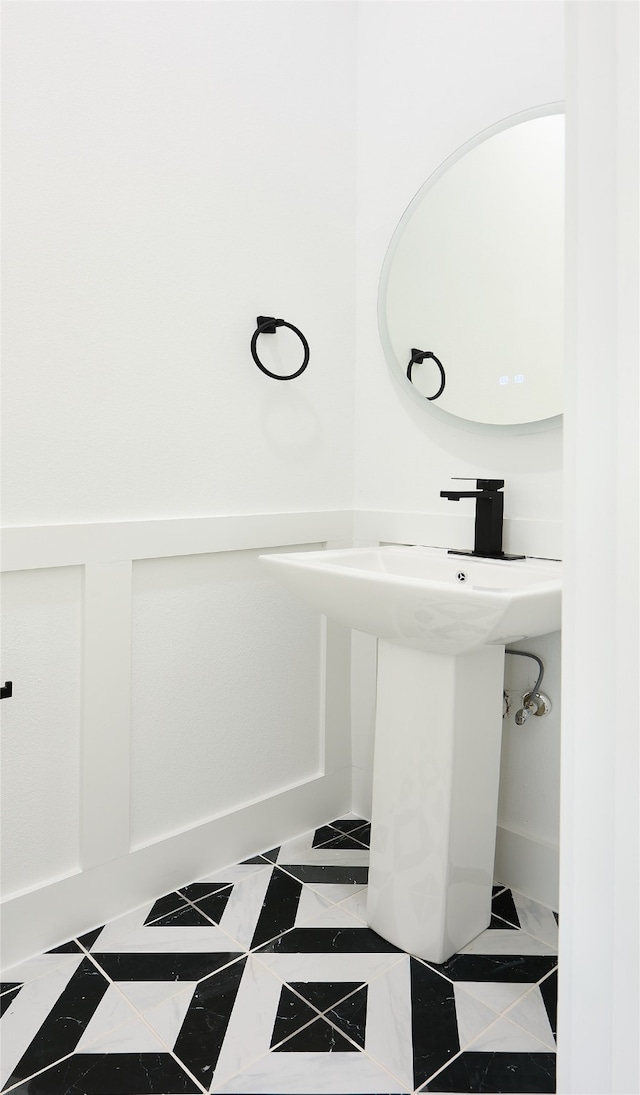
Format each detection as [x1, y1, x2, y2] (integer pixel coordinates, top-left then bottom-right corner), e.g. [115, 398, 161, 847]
[2, 0, 356, 960]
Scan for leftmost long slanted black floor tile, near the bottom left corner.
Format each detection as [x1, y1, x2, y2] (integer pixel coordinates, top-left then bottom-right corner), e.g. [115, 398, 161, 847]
[9, 958, 108, 1085]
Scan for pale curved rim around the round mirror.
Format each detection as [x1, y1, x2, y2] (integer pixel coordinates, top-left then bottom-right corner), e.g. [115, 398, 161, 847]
[378, 103, 564, 435]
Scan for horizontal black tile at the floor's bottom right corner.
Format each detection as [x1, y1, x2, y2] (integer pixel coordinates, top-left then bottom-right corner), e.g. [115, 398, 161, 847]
[422, 1052, 556, 1095]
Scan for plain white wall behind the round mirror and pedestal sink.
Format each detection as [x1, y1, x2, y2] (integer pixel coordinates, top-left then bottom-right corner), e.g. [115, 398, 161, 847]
[354, 0, 564, 903]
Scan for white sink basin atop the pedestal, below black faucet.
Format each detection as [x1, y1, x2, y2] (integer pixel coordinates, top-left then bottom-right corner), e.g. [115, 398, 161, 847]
[261, 546, 561, 654]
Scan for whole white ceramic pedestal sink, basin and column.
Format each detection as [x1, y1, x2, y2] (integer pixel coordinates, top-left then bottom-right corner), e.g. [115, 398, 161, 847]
[261, 545, 561, 963]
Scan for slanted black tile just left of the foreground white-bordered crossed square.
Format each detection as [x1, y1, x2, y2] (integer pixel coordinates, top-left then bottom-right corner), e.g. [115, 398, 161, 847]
[167, 957, 247, 1091]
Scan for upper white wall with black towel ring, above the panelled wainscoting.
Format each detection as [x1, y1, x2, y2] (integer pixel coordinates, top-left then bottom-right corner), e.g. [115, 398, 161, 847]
[3, 0, 355, 525]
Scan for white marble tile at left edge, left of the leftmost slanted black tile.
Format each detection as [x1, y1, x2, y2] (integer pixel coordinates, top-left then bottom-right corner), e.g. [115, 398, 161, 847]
[0, 955, 85, 1085]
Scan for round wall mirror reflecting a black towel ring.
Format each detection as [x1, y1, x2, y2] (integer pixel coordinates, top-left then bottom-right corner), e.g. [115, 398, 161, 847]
[378, 105, 564, 433]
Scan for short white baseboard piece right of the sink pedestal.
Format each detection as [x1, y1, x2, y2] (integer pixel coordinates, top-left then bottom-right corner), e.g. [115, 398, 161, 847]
[494, 826, 560, 910]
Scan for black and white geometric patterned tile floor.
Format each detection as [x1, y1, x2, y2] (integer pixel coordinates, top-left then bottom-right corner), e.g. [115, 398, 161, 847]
[0, 817, 557, 1095]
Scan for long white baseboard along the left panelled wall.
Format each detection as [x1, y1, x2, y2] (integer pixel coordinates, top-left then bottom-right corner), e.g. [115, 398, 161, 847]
[0, 767, 351, 969]
